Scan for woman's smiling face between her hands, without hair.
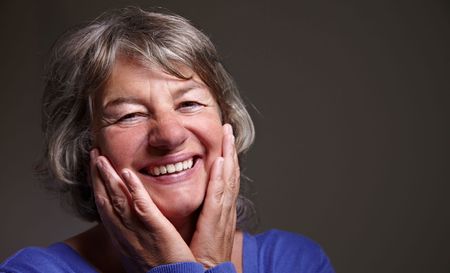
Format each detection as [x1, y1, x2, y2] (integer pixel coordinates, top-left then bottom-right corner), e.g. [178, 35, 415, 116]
[93, 58, 223, 222]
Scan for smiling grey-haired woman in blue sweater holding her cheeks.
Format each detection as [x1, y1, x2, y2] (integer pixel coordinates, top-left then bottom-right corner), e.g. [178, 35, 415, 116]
[0, 8, 333, 273]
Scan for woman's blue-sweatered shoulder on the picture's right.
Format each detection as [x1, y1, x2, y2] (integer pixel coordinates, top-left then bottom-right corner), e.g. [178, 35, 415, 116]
[250, 229, 334, 273]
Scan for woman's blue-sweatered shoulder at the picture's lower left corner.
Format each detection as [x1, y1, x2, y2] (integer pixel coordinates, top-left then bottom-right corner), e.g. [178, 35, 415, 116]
[0, 243, 93, 273]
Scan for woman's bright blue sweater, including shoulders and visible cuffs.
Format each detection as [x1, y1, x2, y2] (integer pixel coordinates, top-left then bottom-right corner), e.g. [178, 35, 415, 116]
[0, 230, 334, 273]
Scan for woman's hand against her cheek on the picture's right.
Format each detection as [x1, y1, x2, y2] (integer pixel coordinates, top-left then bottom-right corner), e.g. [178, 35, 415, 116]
[189, 124, 240, 268]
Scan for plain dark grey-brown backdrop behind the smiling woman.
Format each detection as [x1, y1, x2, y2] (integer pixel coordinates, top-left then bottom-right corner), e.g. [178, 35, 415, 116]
[0, 0, 450, 273]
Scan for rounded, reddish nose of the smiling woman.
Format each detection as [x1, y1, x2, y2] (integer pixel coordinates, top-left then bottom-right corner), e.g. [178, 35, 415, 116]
[148, 115, 188, 151]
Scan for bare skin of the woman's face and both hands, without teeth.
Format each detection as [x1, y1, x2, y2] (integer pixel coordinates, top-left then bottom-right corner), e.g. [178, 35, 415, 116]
[85, 58, 242, 272]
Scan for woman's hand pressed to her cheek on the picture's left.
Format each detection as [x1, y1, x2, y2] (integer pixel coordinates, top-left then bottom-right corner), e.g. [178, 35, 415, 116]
[90, 149, 196, 272]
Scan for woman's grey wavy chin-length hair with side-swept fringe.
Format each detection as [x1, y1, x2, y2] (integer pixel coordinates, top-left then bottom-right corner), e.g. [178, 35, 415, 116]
[36, 7, 256, 229]
